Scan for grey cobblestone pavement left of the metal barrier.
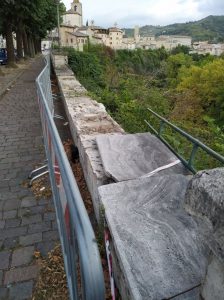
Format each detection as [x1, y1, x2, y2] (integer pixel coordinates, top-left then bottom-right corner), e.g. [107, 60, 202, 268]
[0, 58, 58, 300]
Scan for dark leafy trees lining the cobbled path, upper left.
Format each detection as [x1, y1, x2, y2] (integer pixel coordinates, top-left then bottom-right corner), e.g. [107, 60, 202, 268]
[0, 0, 65, 65]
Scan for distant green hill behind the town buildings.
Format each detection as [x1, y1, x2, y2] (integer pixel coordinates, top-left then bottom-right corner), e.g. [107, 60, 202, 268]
[124, 16, 224, 43]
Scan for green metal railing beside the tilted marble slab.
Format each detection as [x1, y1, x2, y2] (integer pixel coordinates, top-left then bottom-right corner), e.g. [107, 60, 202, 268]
[145, 108, 224, 173]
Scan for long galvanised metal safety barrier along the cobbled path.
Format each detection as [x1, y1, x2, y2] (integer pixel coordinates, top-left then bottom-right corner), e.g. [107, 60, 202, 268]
[36, 57, 105, 300]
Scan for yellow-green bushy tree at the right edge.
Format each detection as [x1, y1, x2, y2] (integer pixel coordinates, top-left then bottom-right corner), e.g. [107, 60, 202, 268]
[177, 58, 224, 126]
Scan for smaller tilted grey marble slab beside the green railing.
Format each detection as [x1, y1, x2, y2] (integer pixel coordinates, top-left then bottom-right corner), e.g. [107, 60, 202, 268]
[96, 133, 188, 182]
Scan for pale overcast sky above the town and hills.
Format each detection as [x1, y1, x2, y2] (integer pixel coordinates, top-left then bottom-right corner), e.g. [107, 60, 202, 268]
[63, 0, 224, 27]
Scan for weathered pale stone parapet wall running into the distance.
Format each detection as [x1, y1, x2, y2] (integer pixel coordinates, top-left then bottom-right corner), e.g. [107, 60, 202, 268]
[52, 55, 124, 222]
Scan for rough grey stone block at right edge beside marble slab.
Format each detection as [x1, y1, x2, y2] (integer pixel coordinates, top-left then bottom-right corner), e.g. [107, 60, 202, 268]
[185, 168, 224, 264]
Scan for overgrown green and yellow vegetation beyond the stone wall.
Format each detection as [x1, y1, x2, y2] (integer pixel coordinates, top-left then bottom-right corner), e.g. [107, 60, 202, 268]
[68, 45, 224, 169]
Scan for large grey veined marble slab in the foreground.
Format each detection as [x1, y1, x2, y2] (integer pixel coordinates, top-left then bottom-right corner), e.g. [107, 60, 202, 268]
[99, 175, 211, 300]
